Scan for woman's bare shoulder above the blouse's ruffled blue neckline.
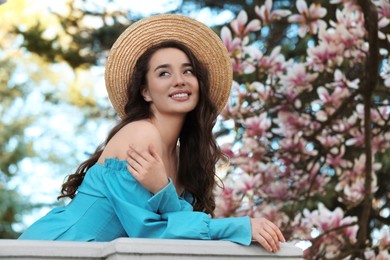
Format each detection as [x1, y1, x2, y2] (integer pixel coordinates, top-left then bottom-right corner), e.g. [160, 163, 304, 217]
[99, 120, 162, 161]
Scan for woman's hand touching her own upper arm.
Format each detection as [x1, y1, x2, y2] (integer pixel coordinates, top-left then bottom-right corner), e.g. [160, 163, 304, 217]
[126, 145, 169, 194]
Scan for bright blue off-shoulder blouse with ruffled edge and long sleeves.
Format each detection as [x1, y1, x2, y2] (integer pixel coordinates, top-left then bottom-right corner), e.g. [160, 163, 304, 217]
[19, 158, 251, 245]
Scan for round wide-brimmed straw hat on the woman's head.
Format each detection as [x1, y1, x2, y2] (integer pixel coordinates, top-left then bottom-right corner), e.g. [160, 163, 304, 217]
[105, 14, 232, 117]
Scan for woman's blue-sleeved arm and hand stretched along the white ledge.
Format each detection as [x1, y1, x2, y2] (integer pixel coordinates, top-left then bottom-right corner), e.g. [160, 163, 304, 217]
[100, 157, 284, 252]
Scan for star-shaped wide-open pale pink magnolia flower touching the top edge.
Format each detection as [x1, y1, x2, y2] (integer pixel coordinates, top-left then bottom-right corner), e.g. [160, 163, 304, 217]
[288, 0, 326, 37]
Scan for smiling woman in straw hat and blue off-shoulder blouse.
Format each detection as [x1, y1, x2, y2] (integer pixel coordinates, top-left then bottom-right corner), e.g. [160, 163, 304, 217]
[20, 15, 285, 252]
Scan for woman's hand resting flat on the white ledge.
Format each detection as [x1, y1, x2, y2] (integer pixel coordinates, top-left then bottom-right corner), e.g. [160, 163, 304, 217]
[251, 218, 286, 252]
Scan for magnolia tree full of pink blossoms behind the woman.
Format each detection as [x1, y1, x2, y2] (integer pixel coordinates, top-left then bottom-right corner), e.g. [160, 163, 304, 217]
[216, 0, 390, 259]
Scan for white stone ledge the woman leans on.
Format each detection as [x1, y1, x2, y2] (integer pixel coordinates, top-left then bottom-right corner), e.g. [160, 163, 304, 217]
[0, 238, 303, 260]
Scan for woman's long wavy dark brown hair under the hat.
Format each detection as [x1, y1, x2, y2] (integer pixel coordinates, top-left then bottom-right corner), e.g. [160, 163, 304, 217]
[58, 41, 226, 216]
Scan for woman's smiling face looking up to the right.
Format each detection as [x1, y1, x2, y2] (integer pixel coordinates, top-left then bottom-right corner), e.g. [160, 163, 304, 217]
[142, 48, 199, 114]
